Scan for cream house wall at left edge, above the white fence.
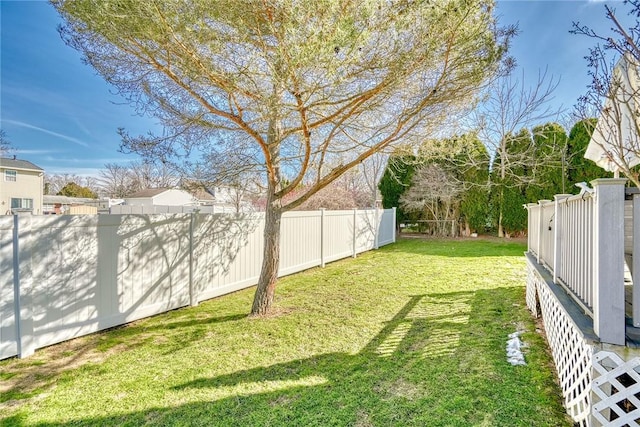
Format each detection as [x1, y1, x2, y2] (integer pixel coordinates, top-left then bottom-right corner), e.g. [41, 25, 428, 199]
[0, 166, 44, 215]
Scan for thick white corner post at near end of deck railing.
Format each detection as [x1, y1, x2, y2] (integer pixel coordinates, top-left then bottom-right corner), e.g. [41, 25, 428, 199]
[591, 178, 627, 345]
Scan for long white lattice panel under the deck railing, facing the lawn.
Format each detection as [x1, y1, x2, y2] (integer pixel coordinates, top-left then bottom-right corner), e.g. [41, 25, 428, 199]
[527, 266, 593, 427]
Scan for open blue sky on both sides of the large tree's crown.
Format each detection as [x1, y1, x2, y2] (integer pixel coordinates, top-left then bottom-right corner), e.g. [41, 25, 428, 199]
[0, 0, 626, 175]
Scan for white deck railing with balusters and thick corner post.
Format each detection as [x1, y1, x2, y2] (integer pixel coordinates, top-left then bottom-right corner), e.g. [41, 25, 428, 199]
[526, 179, 628, 345]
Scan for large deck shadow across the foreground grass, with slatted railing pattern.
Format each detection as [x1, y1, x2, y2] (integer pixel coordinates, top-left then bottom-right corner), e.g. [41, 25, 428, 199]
[5, 288, 568, 427]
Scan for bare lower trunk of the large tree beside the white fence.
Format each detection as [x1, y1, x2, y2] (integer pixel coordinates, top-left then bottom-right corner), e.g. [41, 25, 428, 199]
[251, 195, 282, 316]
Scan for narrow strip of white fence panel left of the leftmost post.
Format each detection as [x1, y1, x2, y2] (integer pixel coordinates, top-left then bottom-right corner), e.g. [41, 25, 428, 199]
[0, 216, 18, 359]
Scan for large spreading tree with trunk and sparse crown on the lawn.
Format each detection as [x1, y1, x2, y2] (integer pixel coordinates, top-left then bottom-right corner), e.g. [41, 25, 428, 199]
[57, 0, 512, 315]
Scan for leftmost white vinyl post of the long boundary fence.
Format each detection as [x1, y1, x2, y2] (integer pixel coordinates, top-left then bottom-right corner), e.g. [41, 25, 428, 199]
[13, 215, 35, 359]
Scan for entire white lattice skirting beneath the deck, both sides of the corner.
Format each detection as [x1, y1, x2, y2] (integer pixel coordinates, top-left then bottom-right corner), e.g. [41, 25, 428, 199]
[526, 259, 640, 427]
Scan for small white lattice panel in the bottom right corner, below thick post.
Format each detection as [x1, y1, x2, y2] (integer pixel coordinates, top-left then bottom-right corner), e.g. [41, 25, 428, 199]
[592, 351, 640, 427]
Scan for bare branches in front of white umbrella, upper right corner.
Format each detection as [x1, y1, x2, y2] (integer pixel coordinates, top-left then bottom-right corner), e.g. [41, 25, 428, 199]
[572, 0, 640, 187]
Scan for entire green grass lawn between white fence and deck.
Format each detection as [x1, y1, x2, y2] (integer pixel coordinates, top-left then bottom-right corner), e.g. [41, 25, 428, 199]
[0, 239, 571, 427]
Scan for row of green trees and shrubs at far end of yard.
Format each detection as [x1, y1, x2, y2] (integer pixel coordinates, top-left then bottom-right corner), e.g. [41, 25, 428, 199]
[379, 119, 611, 236]
